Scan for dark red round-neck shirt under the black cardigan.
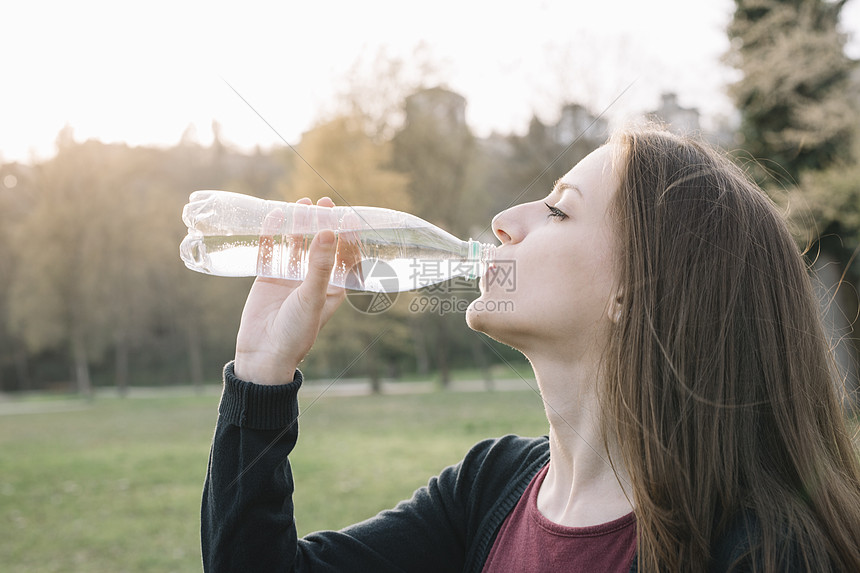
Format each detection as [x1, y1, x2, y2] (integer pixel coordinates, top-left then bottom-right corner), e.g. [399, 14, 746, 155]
[483, 465, 636, 573]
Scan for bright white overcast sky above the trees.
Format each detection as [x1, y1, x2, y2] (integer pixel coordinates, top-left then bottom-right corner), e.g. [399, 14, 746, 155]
[0, 0, 860, 162]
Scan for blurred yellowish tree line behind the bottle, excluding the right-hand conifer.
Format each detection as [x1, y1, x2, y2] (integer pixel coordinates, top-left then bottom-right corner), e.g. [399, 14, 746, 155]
[0, 81, 606, 395]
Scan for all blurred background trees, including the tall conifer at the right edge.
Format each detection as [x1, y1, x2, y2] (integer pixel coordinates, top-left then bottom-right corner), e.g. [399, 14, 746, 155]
[0, 5, 860, 394]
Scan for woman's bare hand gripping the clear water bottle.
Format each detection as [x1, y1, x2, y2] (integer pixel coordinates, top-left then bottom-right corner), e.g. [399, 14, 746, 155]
[233, 197, 345, 384]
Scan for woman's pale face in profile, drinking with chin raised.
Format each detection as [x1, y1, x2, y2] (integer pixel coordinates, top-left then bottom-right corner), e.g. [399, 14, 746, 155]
[466, 146, 618, 356]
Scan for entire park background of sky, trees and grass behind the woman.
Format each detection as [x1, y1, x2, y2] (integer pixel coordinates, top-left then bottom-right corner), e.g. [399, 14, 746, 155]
[0, 0, 860, 571]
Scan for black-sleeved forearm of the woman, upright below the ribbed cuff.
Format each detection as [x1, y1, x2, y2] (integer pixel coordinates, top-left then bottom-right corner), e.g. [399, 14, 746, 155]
[201, 364, 302, 571]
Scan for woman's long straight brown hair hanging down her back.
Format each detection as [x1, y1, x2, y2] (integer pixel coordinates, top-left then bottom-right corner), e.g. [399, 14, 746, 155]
[601, 127, 860, 571]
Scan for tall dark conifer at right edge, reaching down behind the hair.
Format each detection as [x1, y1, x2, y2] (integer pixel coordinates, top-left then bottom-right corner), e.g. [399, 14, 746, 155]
[728, 0, 860, 398]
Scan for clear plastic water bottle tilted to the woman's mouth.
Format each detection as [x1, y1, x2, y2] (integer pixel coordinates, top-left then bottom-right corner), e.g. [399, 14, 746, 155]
[179, 191, 495, 292]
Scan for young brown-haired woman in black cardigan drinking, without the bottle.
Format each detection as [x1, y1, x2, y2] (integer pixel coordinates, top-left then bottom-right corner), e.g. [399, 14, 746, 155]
[202, 128, 860, 572]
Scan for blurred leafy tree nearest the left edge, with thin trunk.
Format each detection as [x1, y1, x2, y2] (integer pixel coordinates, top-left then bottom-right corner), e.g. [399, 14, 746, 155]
[9, 136, 131, 396]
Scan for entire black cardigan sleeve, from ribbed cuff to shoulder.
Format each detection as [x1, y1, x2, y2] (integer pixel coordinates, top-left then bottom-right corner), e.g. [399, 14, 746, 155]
[201, 365, 488, 573]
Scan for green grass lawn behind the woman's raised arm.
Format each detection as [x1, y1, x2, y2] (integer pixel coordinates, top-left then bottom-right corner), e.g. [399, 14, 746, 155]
[0, 382, 546, 573]
